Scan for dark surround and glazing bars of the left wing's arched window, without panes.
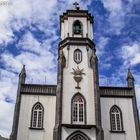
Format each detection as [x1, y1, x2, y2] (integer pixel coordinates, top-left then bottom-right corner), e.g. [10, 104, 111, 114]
[30, 102, 44, 130]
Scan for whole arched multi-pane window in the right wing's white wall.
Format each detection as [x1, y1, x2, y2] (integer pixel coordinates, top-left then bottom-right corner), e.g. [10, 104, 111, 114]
[110, 105, 123, 131]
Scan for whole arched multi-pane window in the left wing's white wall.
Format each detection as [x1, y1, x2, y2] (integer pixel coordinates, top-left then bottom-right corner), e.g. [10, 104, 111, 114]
[31, 102, 44, 128]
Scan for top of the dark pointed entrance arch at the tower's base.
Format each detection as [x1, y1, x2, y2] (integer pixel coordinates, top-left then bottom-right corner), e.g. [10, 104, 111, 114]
[66, 131, 90, 140]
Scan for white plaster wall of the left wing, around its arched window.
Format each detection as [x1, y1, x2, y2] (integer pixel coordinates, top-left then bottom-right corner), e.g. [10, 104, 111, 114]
[17, 95, 56, 140]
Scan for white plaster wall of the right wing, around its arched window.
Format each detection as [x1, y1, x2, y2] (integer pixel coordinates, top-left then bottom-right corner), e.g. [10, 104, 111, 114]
[101, 97, 136, 140]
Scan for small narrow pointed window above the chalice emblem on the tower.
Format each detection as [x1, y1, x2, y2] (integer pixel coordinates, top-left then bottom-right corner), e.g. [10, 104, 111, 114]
[73, 49, 82, 64]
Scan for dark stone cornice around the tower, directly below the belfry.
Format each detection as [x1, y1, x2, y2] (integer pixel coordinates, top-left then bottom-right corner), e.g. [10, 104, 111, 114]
[59, 37, 95, 50]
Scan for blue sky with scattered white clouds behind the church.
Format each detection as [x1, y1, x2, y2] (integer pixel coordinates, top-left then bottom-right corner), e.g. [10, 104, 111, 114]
[0, 0, 140, 137]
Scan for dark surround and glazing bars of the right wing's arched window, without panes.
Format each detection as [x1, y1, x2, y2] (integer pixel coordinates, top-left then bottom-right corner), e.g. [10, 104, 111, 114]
[110, 105, 124, 133]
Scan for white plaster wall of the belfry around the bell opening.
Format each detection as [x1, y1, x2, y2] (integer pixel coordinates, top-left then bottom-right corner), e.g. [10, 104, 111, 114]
[61, 17, 93, 40]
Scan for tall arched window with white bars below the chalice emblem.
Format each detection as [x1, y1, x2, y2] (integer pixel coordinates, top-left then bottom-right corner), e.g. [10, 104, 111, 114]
[71, 93, 86, 124]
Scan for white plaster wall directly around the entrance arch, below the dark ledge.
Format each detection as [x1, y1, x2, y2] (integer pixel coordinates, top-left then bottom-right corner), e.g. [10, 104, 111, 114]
[62, 127, 96, 140]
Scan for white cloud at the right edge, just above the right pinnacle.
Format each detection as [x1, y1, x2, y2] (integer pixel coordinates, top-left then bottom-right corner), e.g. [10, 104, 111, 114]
[121, 42, 140, 67]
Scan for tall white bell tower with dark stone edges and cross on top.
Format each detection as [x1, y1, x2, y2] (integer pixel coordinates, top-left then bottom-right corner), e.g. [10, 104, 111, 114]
[53, 3, 103, 140]
